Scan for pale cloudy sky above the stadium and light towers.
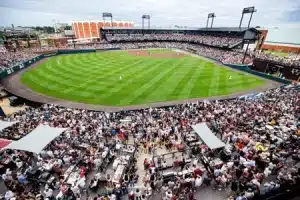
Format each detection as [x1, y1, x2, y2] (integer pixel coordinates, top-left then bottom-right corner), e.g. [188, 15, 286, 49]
[0, 0, 300, 27]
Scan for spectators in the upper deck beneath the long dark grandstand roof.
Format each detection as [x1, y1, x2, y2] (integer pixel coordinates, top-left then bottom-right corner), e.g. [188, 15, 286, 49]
[106, 34, 243, 47]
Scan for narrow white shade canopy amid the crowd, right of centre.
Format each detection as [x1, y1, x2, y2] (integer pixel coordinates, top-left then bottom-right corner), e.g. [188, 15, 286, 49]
[192, 123, 225, 149]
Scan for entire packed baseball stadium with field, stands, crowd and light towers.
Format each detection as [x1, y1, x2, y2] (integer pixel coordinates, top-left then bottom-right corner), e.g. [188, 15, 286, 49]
[0, 2, 300, 200]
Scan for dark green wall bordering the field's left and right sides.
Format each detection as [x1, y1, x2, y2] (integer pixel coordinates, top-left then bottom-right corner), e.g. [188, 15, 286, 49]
[0, 48, 291, 84]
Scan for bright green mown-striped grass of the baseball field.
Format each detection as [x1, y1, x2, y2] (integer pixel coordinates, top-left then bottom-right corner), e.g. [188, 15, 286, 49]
[21, 50, 265, 106]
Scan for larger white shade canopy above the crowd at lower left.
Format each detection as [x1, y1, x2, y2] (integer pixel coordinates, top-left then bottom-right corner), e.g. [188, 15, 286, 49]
[8, 124, 67, 154]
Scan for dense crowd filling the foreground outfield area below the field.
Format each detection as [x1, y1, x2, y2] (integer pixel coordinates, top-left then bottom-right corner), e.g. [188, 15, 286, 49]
[0, 81, 300, 200]
